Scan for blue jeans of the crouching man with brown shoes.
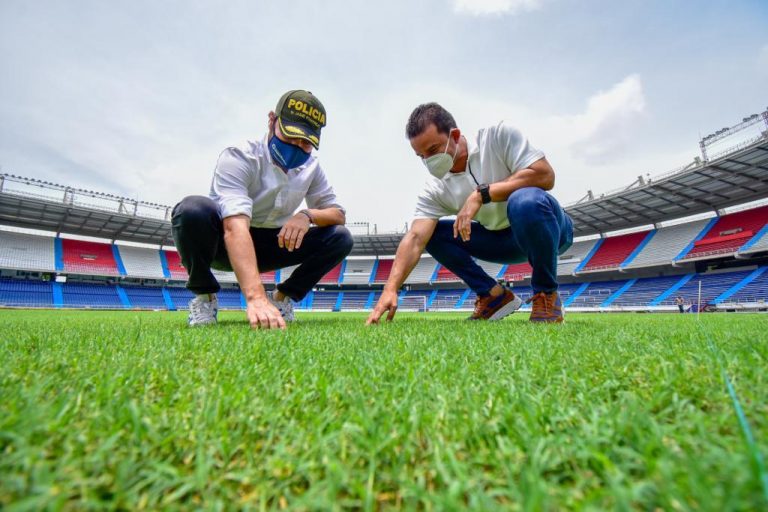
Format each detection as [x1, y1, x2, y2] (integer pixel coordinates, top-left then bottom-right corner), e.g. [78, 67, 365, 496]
[427, 187, 573, 296]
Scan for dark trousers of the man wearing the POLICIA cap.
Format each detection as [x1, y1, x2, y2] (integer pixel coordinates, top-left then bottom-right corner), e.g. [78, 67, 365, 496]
[171, 196, 353, 301]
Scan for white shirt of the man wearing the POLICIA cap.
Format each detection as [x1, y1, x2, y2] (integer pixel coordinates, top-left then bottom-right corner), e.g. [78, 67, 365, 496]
[209, 137, 343, 228]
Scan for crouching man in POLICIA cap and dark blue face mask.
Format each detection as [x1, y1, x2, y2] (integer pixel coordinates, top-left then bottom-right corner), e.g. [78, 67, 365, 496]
[172, 90, 352, 329]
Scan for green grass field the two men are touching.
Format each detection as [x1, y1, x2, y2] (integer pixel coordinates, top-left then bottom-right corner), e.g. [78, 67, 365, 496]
[0, 310, 768, 511]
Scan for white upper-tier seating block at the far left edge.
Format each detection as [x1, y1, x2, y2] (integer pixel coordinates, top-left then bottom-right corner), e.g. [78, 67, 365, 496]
[0, 231, 56, 272]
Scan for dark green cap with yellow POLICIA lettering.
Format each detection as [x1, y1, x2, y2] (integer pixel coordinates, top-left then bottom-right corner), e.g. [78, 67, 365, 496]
[275, 89, 325, 149]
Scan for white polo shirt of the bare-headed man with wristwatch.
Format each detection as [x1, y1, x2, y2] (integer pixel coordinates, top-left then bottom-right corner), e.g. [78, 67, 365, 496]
[414, 121, 544, 231]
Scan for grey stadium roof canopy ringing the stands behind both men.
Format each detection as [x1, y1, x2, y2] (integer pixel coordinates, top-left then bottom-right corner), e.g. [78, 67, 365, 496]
[0, 110, 768, 256]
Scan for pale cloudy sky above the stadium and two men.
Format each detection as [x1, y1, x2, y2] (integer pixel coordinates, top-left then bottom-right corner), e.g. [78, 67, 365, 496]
[0, 0, 768, 230]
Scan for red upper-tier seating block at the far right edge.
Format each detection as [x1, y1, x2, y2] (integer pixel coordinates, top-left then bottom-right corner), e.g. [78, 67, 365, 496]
[683, 206, 768, 259]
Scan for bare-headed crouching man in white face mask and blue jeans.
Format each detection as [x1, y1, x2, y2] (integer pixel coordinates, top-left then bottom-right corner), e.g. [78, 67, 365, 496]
[367, 103, 573, 324]
